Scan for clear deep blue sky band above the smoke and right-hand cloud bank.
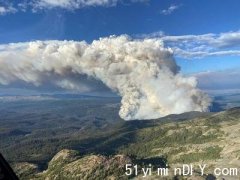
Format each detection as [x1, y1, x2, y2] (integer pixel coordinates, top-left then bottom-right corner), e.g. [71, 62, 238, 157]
[0, 0, 240, 43]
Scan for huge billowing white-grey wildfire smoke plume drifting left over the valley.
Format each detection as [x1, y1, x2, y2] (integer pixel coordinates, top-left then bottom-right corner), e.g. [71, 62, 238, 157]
[0, 35, 210, 120]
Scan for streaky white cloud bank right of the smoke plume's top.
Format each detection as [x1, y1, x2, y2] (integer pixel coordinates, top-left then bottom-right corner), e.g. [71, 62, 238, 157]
[138, 31, 240, 59]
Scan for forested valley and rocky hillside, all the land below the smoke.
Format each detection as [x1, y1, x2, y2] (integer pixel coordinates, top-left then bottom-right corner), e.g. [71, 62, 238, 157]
[0, 97, 240, 179]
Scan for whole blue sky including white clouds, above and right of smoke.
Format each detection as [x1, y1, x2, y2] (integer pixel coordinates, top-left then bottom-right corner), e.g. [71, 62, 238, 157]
[0, 0, 240, 93]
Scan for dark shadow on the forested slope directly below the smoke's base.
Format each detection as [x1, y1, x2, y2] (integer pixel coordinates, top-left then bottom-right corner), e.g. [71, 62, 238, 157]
[71, 120, 154, 155]
